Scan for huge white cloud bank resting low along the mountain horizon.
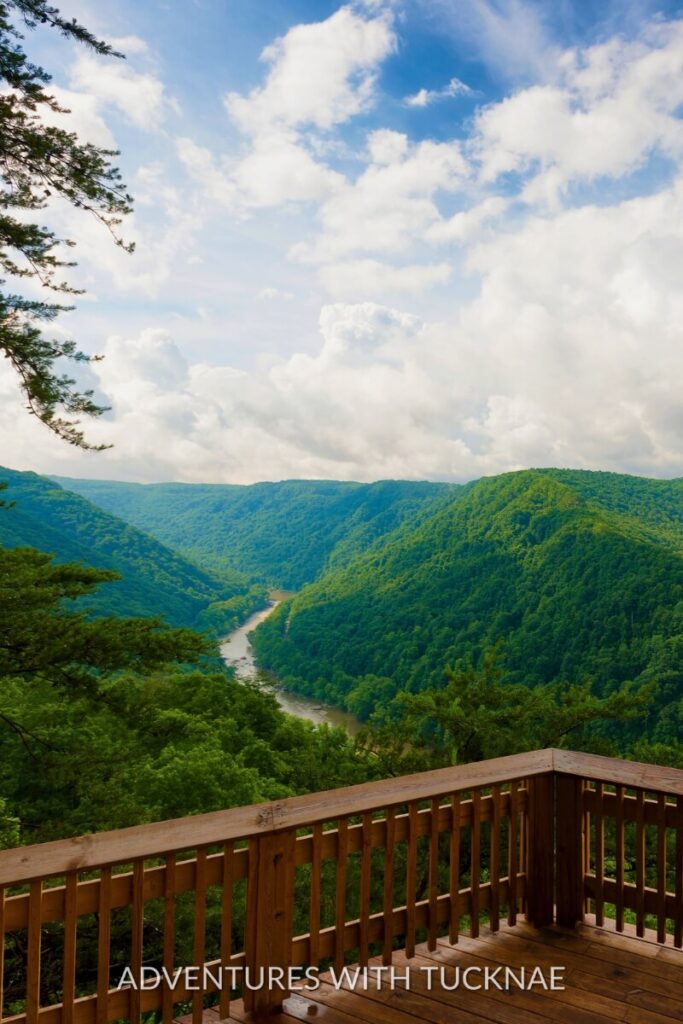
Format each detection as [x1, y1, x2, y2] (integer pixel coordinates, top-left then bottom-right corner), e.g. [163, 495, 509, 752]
[5, 166, 683, 481]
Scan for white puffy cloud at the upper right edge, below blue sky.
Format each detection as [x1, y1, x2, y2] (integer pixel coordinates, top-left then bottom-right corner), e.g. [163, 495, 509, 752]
[473, 22, 683, 193]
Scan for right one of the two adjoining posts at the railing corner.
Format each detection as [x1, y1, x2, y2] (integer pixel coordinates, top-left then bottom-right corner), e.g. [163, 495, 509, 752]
[555, 772, 586, 928]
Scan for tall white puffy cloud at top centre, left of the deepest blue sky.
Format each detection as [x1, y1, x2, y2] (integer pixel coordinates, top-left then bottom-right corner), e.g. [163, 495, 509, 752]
[179, 6, 395, 213]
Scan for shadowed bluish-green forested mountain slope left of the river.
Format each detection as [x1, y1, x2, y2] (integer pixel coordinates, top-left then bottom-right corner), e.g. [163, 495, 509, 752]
[0, 469, 265, 631]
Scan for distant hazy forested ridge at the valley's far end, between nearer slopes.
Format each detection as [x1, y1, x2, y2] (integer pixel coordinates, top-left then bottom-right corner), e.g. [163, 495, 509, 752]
[57, 477, 460, 590]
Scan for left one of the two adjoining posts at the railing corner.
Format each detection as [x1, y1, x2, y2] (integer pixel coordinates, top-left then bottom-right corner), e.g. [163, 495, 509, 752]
[526, 772, 555, 928]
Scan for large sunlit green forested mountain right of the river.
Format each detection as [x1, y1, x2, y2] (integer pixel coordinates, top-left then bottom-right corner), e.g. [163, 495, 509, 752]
[255, 470, 683, 728]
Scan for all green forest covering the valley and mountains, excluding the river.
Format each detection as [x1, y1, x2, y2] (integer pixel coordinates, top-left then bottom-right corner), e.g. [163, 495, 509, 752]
[0, 460, 683, 844]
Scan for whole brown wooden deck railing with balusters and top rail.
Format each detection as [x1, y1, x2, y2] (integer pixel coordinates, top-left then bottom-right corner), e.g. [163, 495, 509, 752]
[0, 750, 683, 1024]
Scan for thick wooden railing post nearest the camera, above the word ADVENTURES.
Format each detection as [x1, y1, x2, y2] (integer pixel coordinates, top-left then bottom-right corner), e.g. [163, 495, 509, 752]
[244, 828, 296, 1020]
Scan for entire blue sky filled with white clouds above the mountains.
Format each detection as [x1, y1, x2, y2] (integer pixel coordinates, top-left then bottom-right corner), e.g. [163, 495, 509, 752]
[0, 0, 683, 483]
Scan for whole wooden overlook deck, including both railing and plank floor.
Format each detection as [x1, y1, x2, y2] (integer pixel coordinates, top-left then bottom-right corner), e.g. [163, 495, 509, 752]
[0, 750, 683, 1024]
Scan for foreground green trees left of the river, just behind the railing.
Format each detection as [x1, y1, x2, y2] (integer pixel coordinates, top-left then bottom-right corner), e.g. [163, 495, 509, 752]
[0, 548, 367, 845]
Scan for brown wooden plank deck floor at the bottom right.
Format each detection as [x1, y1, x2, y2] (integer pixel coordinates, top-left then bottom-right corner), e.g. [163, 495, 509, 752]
[182, 924, 683, 1024]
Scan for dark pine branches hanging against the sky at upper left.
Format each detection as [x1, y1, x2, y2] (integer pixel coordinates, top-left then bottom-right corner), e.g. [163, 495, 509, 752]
[0, 0, 132, 447]
